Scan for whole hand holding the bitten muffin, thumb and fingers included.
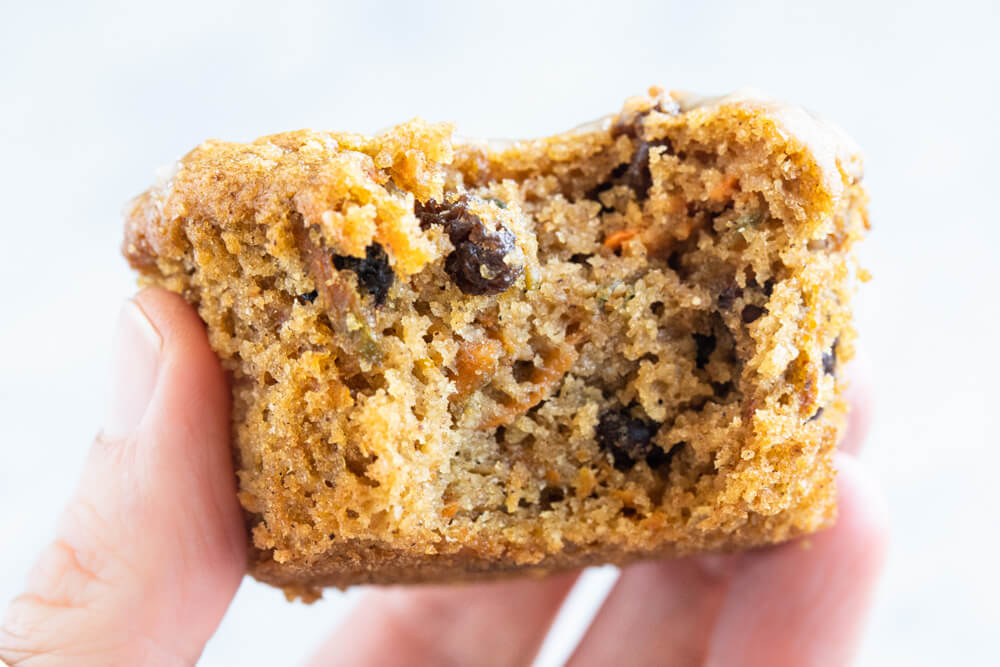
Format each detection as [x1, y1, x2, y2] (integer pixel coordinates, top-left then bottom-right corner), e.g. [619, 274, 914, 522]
[0, 289, 886, 667]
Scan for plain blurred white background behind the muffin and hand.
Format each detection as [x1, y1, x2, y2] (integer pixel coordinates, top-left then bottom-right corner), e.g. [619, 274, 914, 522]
[0, 0, 1000, 665]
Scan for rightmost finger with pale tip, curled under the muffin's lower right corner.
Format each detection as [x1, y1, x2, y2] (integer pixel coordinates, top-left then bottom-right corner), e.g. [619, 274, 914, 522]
[710, 455, 888, 665]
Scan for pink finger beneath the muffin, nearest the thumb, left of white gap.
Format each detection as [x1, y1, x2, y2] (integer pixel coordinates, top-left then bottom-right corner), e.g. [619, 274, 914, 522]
[311, 574, 577, 667]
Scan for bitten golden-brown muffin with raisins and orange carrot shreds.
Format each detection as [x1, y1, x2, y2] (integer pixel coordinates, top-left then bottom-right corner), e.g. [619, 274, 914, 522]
[124, 88, 868, 599]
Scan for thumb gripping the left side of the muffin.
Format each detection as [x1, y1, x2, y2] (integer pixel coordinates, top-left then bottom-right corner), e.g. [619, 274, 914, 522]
[0, 289, 246, 665]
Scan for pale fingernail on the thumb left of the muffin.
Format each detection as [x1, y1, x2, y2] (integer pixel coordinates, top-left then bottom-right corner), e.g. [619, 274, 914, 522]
[103, 299, 163, 440]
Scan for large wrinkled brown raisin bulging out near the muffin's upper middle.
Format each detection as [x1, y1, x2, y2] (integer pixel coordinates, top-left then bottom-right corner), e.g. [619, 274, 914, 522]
[414, 196, 524, 296]
